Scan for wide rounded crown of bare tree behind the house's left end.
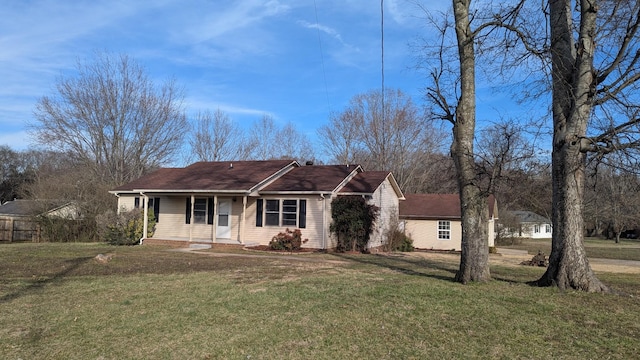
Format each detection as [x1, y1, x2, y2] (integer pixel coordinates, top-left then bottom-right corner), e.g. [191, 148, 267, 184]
[31, 53, 187, 186]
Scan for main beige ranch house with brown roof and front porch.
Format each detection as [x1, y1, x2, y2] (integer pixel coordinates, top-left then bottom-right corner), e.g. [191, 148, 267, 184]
[110, 160, 404, 249]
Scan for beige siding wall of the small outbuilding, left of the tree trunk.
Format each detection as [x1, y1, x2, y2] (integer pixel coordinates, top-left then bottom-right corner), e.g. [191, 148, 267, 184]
[404, 219, 462, 251]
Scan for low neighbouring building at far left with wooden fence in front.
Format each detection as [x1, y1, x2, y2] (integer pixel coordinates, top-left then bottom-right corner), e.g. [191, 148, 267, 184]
[0, 200, 80, 242]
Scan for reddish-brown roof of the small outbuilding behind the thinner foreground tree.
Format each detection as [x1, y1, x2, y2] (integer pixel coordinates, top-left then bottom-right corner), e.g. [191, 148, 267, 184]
[399, 194, 495, 220]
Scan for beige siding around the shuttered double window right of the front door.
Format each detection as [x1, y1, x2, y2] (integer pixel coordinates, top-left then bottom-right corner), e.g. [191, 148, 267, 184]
[244, 195, 329, 249]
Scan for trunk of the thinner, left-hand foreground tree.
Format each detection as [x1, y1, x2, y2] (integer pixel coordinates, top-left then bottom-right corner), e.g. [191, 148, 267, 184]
[451, 0, 491, 284]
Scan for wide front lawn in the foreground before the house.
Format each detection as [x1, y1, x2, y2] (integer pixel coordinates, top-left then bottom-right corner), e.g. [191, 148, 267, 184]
[0, 244, 640, 359]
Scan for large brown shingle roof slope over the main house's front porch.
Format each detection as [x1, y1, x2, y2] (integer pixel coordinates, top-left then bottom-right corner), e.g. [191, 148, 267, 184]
[114, 160, 297, 192]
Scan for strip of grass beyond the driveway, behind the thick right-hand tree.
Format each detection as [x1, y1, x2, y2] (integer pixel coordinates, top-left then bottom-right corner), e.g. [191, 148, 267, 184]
[498, 238, 640, 261]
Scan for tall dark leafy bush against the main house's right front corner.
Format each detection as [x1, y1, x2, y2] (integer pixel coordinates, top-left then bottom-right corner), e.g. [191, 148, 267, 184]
[329, 196, 379, 252]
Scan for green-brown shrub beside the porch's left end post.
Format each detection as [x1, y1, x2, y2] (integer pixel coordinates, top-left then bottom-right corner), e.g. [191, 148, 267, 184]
[96, 209, 156, 245]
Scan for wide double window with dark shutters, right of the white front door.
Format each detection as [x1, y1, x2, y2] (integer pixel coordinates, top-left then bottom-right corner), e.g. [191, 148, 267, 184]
[256, 199, 307, 229]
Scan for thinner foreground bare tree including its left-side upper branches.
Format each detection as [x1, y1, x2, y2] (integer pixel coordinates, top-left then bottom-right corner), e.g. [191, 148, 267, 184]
[427, 0, 491, 283]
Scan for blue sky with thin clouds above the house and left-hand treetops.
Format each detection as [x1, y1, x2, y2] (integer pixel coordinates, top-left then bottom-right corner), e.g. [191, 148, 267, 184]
[0, 0, 536, 159]
